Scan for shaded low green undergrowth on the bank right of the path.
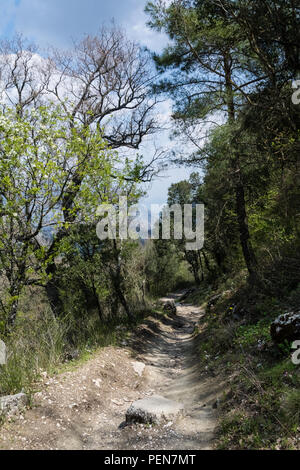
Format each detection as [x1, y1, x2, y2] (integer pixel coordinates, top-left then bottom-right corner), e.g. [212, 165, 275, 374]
[188, 278, 300, 450]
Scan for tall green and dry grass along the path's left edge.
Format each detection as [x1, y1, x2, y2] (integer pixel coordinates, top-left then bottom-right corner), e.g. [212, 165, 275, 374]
[0, 292, 156, 398]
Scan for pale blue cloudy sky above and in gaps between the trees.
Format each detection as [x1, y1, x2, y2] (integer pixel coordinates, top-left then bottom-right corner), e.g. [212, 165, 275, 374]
[0, 0, 195, 205]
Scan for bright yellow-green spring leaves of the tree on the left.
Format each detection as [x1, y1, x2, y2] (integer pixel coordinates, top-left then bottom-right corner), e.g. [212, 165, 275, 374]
[0, 106, 116, 324]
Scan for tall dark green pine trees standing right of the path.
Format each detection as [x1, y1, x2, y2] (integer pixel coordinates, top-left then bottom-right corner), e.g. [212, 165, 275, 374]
[146, 0, 300, 291]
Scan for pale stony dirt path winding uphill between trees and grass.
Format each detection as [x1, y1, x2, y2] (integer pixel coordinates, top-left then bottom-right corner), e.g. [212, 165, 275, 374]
[0, 296, 222, 450]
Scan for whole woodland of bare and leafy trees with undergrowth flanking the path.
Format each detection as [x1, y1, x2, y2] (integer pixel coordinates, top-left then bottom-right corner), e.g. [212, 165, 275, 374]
[0, 0, 300, 450]
